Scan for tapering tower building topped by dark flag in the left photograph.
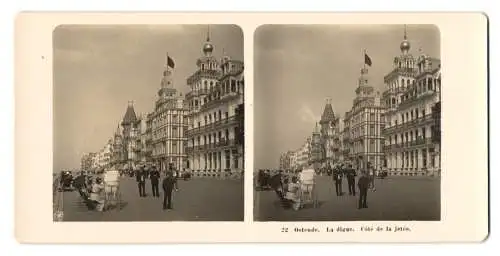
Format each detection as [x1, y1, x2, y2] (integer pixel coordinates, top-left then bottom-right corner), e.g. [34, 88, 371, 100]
[148, 56, 188, 171]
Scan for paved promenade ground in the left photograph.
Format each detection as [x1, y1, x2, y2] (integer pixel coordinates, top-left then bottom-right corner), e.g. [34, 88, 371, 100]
[63, 177, 244, 221]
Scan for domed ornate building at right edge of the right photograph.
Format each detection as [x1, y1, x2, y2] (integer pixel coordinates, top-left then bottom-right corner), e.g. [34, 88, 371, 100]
[383, 29, 441, 176]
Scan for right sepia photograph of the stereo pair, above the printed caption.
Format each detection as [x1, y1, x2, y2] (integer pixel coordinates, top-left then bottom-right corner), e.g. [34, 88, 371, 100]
[253, 24, 442, 221]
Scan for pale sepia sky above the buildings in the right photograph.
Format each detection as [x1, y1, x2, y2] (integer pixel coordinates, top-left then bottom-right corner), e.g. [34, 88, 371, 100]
[254, 25, 440, 169]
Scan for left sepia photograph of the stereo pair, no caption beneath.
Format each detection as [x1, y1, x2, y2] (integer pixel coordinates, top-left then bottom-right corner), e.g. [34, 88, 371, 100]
[52, 24, 245, 221]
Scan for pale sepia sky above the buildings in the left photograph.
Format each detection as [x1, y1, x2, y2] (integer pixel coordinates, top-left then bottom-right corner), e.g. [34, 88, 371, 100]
[53, 25, 243, 171]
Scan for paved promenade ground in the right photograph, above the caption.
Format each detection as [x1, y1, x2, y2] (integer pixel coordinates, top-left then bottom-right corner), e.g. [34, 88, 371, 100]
[254, 176, 441, 221]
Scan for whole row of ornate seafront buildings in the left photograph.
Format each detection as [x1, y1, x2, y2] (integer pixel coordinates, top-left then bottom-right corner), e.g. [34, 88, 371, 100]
[81, 29, 245, 177]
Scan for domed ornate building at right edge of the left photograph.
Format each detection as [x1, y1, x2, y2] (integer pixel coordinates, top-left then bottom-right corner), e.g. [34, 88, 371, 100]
[186, 30, 244, 177]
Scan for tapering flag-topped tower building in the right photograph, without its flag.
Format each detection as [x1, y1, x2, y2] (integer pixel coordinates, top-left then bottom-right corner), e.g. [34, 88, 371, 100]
[343, 66, 385, 169]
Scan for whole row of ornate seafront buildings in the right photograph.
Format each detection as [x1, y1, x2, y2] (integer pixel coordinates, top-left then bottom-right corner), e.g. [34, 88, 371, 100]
[279, 28, 441, 176]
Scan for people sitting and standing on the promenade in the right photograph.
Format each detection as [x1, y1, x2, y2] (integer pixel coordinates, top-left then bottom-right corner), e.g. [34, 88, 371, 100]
[257, 163, 377, 210]
